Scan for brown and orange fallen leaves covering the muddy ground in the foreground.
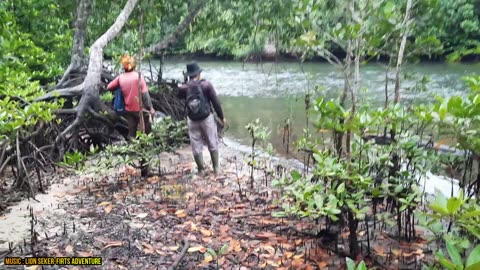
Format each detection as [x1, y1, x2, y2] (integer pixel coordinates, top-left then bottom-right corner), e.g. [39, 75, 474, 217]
[19, 147, 432, 269]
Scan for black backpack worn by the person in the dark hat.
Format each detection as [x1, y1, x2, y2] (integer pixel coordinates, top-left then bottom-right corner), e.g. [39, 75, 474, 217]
[185, 83, 211, 121]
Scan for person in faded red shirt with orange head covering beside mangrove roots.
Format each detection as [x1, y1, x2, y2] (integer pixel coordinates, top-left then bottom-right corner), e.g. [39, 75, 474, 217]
[107, 55, 155, 140]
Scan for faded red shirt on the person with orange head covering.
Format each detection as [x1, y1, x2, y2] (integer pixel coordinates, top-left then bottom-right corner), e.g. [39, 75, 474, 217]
[107, 71, 148, 112]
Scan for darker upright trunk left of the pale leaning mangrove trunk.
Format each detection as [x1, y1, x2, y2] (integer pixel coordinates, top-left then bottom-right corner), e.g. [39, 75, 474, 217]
[55, 0, 92, 88]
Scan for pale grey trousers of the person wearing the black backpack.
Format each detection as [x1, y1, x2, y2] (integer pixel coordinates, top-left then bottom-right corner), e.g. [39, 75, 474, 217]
[188, 114, 218, 156]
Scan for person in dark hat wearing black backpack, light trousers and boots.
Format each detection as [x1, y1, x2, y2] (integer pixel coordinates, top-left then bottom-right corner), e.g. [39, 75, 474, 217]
[177, 62, 226, 175]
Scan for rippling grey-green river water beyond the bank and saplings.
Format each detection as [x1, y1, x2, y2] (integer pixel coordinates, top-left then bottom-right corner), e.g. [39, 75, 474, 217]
[149, 61, 480, 157]
